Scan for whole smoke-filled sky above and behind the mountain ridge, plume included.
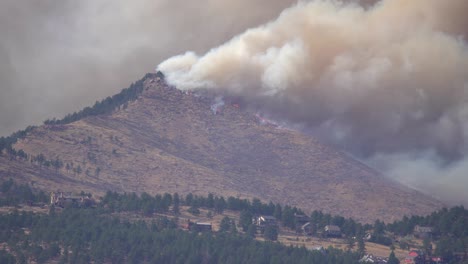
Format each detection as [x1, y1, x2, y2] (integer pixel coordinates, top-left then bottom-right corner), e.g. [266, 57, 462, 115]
[0, 0, 468, 203]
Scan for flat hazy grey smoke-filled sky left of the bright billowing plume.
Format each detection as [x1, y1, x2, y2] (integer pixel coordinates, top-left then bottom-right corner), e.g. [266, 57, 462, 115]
[0, 0, 294, 136]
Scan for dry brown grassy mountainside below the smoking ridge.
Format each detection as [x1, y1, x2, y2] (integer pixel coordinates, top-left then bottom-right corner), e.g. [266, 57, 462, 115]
[5, 77, 441, 221]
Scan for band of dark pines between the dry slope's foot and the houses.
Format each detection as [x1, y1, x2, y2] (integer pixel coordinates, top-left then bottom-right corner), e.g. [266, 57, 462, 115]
[101, 192, 468, 263]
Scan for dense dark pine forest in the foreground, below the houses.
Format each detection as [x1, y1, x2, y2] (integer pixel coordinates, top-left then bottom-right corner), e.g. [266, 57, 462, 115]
[0, 208, 359, 263]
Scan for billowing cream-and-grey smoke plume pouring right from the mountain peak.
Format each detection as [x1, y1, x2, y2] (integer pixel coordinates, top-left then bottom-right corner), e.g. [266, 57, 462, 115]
[158, 0, 468, 203]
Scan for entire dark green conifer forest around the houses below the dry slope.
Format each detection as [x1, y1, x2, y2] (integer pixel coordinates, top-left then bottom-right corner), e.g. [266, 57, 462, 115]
[0, 179, 468, 263]
